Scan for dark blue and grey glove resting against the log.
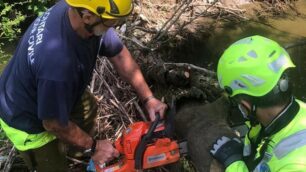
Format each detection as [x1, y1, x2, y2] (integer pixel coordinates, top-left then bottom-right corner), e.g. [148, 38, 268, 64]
[210, 136, 243, 168]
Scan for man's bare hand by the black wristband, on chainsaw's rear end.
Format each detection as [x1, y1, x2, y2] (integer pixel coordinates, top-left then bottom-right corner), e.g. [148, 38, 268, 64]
[91, 140, 120, 164]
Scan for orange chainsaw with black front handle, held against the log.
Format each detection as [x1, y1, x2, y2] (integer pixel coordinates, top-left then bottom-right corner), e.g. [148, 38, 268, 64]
[89, 103, 187, 172]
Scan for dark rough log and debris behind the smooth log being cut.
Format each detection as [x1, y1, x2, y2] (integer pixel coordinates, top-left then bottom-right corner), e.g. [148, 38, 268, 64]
[143, 63, 221, 102]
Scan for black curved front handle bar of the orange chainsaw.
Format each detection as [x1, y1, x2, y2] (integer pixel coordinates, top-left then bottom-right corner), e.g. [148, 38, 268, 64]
[135, 113, 160, 170]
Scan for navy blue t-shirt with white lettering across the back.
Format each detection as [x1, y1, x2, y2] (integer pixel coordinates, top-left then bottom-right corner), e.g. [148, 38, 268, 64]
[0, 0, 123, 134]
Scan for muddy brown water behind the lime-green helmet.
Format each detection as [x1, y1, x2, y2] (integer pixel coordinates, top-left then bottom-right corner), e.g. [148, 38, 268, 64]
[173, 0, 306, 101]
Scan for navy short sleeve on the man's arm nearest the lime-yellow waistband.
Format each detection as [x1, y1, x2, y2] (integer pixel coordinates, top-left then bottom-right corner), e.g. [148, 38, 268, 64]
[37, 79, 76, 125]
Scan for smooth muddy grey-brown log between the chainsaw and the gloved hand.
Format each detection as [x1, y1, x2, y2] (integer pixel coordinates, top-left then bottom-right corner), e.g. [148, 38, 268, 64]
[175, 97, 235, 172]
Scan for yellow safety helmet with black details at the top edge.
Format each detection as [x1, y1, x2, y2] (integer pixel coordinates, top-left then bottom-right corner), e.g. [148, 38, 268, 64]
[66, 0, 133, 19]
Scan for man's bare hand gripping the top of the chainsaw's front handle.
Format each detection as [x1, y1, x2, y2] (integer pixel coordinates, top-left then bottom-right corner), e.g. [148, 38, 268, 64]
[145, 97, 167, 121]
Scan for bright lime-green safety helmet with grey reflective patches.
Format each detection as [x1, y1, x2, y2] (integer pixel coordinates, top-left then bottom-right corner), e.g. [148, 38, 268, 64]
[217, 35, 295, 97]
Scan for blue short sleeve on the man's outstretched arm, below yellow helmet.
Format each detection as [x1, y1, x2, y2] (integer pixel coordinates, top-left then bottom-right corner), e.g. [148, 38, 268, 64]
[99, 28, 123, 57]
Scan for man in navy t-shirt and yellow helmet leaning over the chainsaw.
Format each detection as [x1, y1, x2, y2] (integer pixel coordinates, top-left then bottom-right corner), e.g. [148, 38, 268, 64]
[0, 0, 166, 172]
